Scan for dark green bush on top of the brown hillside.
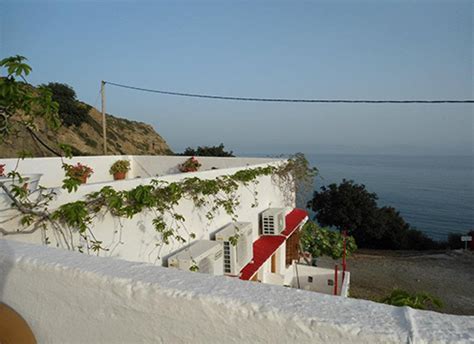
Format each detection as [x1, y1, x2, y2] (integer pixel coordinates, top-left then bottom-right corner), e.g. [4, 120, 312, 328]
[43, 82, 89, 127]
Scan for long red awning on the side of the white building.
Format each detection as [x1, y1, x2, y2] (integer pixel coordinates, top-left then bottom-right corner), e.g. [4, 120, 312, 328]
[239, 209, 308, 281]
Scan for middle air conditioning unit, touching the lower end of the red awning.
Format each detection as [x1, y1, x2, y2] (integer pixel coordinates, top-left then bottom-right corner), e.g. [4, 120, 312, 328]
[216, 222, 253, 276]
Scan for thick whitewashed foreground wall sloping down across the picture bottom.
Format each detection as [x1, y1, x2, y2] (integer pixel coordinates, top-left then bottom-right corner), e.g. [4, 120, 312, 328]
[0, 240, 474, 343]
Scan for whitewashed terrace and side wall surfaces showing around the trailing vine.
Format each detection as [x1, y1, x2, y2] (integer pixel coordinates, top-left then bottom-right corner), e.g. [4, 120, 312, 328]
[0, 157, 294, 264]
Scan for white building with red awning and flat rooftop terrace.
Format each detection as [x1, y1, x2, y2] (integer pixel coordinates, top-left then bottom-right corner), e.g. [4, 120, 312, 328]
[0, 156, 349, 294]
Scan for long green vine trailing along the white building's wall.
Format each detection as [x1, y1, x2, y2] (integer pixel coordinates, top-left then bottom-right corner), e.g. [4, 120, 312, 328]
[0, 151, 318, 252]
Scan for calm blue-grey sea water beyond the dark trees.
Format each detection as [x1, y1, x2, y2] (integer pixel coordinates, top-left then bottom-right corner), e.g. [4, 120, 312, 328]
[306, 154, 474, 240]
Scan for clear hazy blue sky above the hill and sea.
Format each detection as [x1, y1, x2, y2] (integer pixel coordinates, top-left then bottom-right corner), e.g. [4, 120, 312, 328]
[0, 0, 474, 155]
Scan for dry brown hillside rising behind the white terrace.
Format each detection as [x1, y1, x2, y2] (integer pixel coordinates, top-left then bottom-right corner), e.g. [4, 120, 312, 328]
[0, 103, 172, 158]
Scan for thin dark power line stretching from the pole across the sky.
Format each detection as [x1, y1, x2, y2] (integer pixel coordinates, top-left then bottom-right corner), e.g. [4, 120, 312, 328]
[104, 81, 474, 104]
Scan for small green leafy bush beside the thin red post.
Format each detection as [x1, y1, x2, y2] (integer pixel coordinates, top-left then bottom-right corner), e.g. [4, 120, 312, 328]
[300, 221, 357, 259]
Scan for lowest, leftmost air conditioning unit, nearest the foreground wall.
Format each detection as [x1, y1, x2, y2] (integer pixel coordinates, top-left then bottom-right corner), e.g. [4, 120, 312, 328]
[168, 240, 224, 276]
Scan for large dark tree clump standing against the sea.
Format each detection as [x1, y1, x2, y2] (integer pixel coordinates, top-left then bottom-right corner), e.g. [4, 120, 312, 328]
[308, 179, 438, 250]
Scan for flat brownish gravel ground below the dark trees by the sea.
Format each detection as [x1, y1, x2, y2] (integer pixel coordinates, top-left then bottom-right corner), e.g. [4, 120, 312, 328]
[319, 250, 474, 315]
